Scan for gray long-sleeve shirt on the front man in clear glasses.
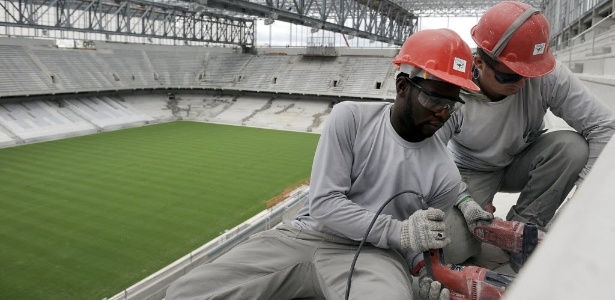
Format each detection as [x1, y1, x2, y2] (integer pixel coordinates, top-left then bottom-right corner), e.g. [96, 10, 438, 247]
[292, 102, 465, 253]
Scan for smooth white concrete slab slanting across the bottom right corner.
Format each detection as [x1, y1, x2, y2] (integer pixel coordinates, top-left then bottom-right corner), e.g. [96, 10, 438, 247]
[505, 135, 615, 300]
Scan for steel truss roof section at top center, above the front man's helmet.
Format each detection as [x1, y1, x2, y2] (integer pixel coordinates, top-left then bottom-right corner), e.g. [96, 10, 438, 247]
[182, 0, 544, 45]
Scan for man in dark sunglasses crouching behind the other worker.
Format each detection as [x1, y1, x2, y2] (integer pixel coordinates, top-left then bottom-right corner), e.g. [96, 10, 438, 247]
[437, 1, 615, 271]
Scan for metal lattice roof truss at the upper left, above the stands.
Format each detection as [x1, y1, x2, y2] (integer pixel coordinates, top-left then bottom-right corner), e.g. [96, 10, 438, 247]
[0, 0, 254, 46]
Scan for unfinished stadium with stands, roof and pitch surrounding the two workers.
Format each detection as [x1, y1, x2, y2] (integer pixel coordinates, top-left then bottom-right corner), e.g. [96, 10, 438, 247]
[0, 0, 615, 300]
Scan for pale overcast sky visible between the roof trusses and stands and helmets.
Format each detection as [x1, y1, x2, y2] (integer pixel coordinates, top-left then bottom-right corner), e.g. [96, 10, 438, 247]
[256, 17, 478, 48]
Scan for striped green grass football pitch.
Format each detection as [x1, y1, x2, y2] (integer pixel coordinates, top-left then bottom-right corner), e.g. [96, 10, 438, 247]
[0, 122, 319, 300]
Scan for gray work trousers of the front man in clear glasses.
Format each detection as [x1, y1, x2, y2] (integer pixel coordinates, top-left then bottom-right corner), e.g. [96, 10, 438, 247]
[166, 225, 412, 300]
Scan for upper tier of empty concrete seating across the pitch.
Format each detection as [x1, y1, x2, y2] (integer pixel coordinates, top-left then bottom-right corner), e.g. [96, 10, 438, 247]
[0, 43, 394, 98]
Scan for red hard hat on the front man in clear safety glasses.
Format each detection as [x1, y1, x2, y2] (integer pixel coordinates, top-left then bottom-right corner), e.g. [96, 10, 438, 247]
[393, 28, 479, 91]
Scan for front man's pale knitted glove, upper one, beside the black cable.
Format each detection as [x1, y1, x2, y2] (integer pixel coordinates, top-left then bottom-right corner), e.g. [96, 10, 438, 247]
[401, 208, 451, 252]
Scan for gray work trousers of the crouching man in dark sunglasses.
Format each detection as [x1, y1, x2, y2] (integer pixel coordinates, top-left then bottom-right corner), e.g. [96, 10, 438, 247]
[444, 130, 589, 264]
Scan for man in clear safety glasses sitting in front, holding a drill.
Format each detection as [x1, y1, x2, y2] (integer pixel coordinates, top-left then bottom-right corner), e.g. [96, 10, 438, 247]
[165, 29, 478, 300]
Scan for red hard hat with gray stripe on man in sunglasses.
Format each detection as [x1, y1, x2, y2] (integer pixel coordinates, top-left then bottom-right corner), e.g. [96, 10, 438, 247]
[472, 1, 555, 77]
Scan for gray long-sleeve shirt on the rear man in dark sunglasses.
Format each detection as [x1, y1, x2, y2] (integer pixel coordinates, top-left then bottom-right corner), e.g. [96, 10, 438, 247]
[436, 63, 615, 179]
